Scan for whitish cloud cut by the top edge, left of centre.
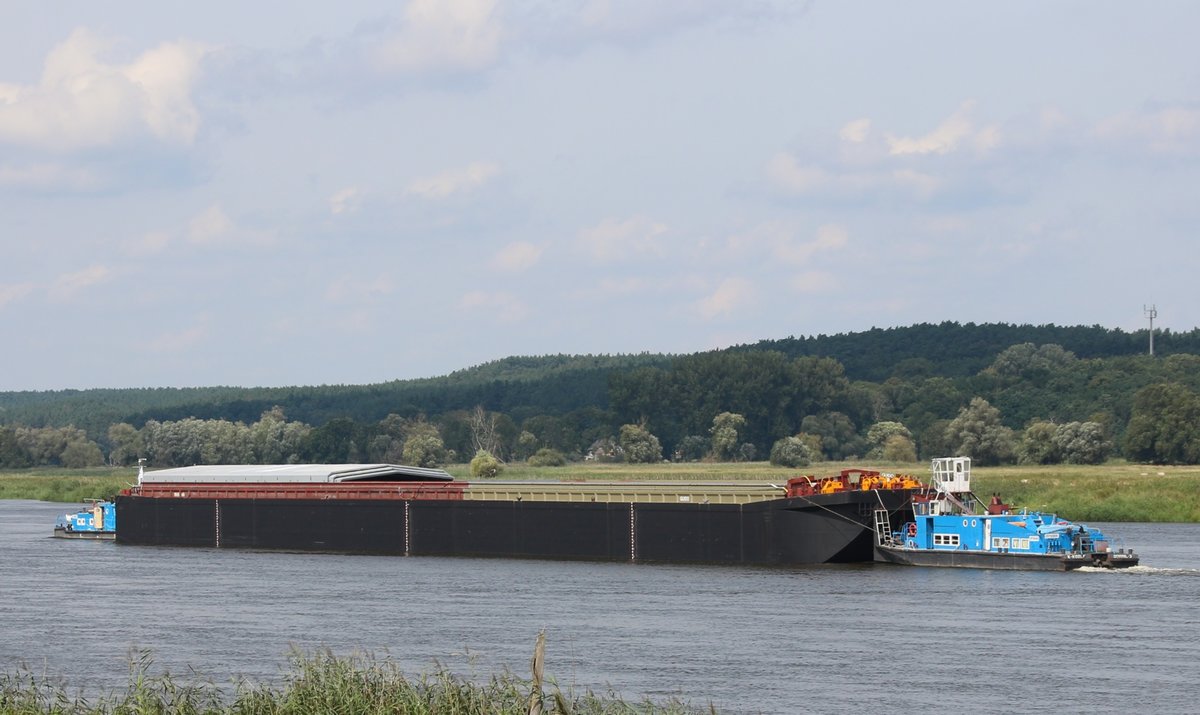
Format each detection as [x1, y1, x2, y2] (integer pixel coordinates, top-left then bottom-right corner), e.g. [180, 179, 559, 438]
[372, 0, 504, 73]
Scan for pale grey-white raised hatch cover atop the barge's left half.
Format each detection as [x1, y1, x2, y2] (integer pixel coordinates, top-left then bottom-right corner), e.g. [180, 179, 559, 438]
[140, 464, 454, 483]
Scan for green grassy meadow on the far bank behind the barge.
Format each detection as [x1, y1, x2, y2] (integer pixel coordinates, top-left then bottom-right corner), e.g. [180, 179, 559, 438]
[0, 462, 1200, 522]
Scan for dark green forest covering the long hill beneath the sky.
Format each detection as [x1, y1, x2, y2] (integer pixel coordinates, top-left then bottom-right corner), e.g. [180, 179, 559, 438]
[0, 323, 1200, 467]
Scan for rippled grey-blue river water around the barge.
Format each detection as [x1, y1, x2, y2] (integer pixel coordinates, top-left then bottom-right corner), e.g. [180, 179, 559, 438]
[0, 500, 1200, 713]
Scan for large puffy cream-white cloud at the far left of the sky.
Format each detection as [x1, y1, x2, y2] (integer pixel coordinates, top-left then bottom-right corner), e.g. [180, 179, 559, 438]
[0, 29, 209, 151]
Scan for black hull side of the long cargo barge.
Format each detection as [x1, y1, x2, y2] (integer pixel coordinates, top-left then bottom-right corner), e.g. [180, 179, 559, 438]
[116, 489, 911, 565]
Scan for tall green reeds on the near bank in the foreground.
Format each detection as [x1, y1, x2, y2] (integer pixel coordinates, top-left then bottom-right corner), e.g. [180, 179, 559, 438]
[0, 637, 715, 715]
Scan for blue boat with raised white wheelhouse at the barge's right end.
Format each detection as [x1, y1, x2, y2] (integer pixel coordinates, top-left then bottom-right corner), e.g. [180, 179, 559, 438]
[875, 457, 1139, 571]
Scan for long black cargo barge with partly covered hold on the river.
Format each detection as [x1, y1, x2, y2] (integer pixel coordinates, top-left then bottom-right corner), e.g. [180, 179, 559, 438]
[116, 464, 923, 565]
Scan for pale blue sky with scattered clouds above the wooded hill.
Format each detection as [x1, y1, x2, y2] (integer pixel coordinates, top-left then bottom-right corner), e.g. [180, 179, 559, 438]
[0, 0, 1200, 390]
